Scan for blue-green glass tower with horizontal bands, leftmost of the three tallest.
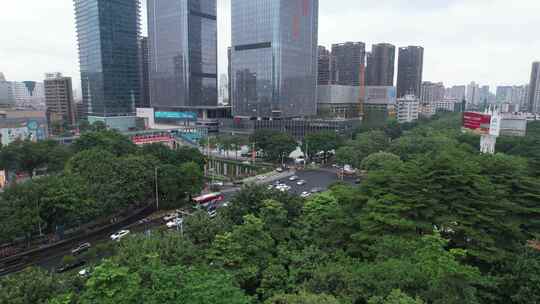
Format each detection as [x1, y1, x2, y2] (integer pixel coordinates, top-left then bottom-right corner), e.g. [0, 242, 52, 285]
[74, 0, 141, 117]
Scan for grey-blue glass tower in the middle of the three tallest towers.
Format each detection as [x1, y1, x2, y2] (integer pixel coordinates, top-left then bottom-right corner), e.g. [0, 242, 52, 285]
[148, 0, 218, 111]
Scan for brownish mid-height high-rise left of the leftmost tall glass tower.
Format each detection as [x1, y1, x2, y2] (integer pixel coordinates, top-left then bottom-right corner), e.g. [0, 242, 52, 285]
[43, 73, 76, 125]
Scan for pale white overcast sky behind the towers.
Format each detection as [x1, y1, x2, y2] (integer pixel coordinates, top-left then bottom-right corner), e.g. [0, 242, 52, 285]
[0, 0, 540, 95]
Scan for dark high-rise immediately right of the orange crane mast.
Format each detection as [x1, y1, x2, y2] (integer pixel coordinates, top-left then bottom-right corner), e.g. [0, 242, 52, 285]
[366, 43, 396, 86]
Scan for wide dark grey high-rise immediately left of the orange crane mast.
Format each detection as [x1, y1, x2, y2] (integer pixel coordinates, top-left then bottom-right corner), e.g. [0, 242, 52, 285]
[330, 42, 366, 86]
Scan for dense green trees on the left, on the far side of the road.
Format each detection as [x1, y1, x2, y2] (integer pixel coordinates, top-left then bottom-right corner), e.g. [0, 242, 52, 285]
[0, 130, 204, 242]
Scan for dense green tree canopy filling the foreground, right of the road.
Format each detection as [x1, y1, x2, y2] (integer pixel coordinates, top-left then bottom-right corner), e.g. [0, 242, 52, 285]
[0, 116, 540, 304]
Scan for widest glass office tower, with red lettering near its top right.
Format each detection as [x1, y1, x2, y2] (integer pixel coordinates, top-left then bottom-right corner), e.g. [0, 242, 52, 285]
[231, 0, 319, 118]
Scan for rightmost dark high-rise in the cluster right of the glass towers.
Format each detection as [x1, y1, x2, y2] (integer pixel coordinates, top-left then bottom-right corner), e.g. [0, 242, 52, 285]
[397, 46, 424, 98]
